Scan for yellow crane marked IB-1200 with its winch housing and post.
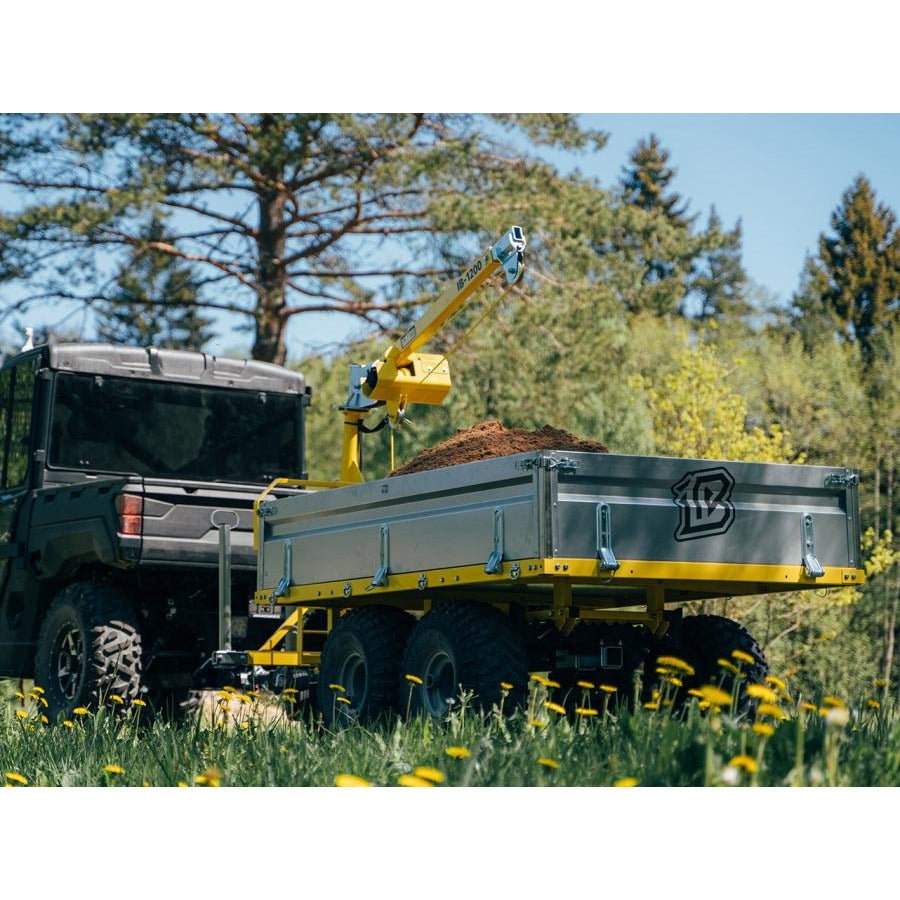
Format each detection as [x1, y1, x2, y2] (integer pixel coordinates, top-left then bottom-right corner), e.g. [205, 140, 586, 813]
[341, 225, 525, 482]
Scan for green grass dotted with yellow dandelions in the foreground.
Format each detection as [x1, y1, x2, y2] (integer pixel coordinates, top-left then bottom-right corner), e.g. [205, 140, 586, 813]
[0, 661, 900, 787]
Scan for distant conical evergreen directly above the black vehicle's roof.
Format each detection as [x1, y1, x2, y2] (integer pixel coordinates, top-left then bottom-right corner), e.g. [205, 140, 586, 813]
[95, 218, 213, 350]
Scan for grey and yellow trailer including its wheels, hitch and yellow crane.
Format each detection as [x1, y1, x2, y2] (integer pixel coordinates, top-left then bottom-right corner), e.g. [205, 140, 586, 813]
[201, 228, 865, 722]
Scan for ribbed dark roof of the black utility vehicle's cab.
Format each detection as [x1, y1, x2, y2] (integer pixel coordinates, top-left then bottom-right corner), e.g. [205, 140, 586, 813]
[7, 343, 306, 394]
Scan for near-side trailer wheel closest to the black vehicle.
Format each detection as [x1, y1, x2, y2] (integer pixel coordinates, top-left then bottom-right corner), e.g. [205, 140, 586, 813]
[318, 606, 414, 725]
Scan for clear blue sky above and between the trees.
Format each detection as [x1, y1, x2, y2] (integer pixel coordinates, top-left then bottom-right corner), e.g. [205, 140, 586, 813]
[0, 114, 900, 358]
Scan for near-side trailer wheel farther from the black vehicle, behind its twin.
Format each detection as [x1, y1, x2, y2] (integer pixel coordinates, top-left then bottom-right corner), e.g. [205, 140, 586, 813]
[401, 601, 528, 718]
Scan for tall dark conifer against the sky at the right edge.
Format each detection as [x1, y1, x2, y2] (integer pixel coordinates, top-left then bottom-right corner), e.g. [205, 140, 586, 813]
[795, 175, 900, 361]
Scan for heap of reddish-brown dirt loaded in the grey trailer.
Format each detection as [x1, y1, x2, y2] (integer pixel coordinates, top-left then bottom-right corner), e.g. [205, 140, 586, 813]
[391, 419, 609, 475]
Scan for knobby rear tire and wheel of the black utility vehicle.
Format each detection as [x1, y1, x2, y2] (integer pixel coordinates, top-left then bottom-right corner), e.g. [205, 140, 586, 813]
[34, 582, 141, 721]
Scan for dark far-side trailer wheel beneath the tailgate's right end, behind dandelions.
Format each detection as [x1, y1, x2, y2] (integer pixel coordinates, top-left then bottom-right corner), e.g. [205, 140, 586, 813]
[676, 615, 769, 711]
